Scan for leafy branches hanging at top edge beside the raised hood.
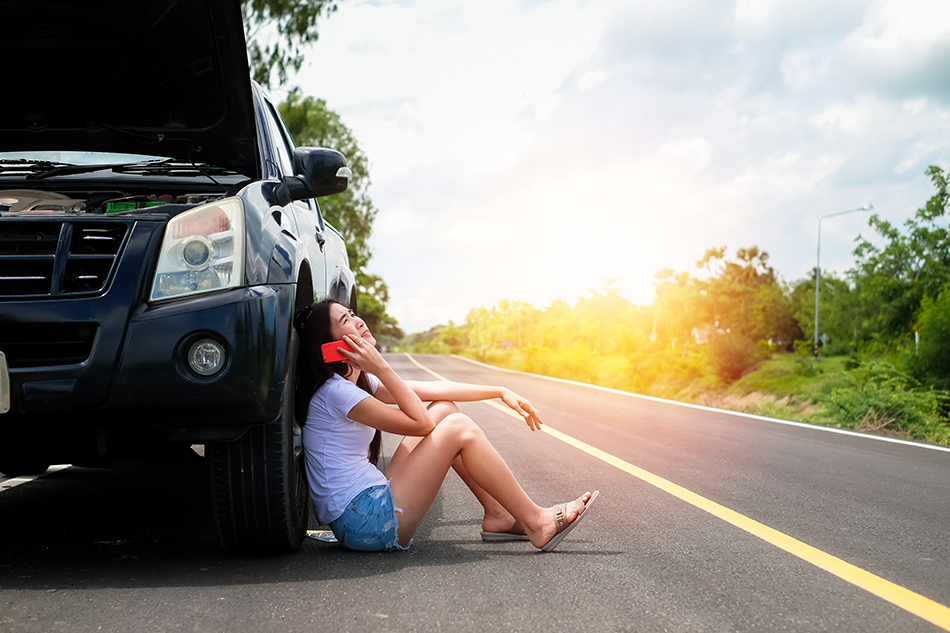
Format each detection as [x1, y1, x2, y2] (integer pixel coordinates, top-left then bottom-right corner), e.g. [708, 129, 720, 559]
[241, 0, 336, 87]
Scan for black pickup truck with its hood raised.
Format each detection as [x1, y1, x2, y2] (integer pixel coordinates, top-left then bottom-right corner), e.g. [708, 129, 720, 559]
[0, 0, 356, 552]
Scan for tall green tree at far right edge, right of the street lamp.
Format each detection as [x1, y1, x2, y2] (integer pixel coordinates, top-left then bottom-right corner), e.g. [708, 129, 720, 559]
[849, 166, 950, 344]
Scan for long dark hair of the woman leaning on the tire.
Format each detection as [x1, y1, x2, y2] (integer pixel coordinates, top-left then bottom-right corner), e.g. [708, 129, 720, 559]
[294, 299, 383, 464]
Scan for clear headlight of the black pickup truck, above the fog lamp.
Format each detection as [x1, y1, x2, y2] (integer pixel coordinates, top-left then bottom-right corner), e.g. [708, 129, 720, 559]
[151, 198, 244, 301]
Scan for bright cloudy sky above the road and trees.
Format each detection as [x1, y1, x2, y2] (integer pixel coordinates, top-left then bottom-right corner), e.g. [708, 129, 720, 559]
[282, 0, 950, 333]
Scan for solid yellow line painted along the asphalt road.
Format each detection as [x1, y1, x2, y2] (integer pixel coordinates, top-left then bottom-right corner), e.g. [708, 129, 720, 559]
[406, 354, 950, 631]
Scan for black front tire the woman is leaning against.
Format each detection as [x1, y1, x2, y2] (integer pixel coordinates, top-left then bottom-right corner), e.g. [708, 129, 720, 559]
[207, 328, 310, 554]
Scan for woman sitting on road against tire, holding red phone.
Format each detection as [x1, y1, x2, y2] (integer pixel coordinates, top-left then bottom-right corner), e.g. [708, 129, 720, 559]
[297, 300, 597, 552]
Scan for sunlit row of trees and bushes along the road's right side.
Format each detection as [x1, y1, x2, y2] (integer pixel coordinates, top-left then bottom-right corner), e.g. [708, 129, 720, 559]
[405, 166, 950, 439]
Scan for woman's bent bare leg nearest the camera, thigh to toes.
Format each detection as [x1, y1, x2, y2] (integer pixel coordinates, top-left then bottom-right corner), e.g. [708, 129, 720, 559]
[386, 413, 589, 547]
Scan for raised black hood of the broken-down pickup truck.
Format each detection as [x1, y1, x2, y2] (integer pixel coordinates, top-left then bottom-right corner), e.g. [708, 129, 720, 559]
[0, 0, 261, 178]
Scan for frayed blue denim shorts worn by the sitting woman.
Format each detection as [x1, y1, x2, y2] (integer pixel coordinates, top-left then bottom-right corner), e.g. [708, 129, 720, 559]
[330, 484, 409, 552]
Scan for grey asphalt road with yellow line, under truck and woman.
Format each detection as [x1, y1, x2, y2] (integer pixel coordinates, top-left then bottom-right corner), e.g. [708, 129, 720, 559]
[0, 355, 950, 633]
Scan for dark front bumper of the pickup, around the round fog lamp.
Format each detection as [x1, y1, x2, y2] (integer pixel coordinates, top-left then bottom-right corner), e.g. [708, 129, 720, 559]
[0, 284, 295, 442]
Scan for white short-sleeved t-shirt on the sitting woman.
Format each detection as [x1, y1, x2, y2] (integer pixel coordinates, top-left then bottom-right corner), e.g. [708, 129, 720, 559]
[303, 374, 387, 524]
